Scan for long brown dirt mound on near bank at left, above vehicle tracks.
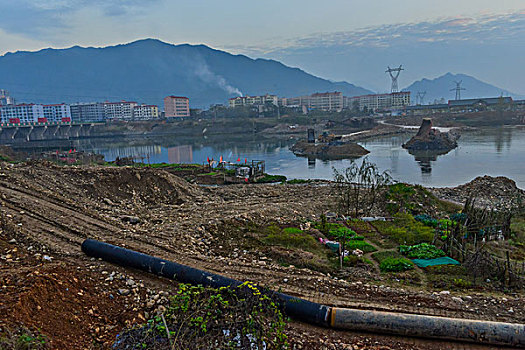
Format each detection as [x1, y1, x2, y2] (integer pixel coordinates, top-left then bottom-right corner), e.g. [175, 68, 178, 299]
[4, 162, 202, 205]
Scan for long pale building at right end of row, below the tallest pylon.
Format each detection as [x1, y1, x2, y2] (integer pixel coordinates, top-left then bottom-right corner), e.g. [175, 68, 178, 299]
[348, 91, 410, 111]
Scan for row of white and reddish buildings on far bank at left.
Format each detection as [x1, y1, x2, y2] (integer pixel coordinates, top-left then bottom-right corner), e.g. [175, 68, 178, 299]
[0, 90, 190, 124]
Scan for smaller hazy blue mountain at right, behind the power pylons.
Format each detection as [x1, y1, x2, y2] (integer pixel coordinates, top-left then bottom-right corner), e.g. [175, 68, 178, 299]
[403, 73, 523, 104]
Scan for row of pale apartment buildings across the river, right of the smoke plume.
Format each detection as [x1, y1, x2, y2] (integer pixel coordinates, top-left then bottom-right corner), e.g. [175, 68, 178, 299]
[229, 91, 410, 112]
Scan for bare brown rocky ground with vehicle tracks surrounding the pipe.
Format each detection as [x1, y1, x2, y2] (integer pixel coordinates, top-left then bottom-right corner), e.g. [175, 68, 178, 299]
[0, 162, 525, 349]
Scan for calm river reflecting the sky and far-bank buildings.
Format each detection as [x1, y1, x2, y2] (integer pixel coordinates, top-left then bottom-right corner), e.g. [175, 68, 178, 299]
[12, 127, 525, 188]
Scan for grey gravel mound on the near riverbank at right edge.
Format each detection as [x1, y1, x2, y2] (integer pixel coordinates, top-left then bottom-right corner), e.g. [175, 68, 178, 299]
[432, 175, 525, 210]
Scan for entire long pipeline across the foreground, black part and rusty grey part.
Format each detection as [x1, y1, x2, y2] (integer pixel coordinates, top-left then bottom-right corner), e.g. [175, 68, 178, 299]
[82, 239, 525, 347]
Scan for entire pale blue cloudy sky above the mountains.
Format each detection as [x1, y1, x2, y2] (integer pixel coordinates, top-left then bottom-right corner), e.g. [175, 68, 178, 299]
[0, 0, 525, 95]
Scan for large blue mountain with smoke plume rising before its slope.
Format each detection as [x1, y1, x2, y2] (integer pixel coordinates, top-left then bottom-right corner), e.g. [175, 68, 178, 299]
[0, 39, 371, 107]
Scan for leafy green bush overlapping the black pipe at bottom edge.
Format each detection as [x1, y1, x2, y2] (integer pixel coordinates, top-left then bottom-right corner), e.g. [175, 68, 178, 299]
[112, 282, 288, 350]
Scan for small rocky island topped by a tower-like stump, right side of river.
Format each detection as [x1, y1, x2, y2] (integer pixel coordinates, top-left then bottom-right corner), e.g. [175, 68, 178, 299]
[403, 118, 459, 154]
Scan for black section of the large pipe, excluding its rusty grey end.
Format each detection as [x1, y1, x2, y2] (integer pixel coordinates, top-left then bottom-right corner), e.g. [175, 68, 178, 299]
[82, 239, 330, 326]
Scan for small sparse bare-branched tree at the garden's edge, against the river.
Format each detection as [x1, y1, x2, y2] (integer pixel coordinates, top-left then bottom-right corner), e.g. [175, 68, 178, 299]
[333, 158, 392, 217]
